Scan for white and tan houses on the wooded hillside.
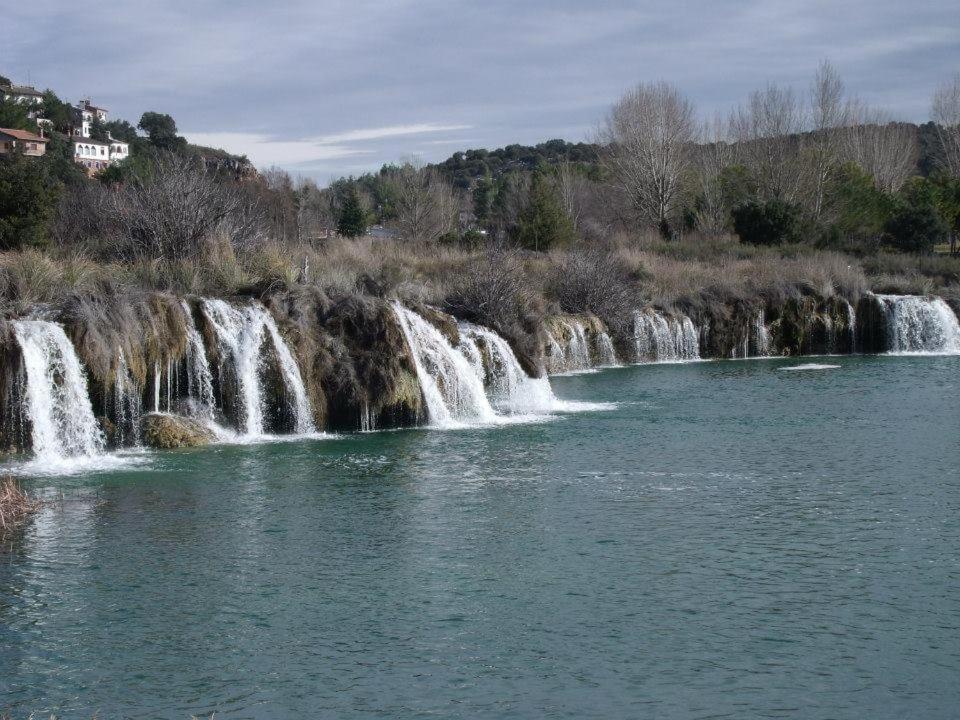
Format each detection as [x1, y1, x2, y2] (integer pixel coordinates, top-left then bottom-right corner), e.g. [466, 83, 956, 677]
[0, 84, 130, 175]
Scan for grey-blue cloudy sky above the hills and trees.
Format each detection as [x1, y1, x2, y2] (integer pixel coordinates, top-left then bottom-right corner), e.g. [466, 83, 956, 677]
[0, 0, 960, 182]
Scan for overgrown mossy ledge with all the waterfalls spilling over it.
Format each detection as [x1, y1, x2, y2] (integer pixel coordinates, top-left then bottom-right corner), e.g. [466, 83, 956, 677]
[0, 250, 960, 464]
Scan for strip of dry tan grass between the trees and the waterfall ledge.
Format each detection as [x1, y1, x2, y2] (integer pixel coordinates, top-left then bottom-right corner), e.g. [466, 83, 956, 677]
[0, 233, 960, 324]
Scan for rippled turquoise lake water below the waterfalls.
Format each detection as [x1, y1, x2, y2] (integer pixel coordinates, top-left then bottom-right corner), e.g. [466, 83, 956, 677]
[0, 357, 960, 718]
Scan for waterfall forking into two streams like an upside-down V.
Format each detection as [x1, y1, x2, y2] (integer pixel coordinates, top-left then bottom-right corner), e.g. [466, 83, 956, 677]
[203, 299, 315, 437]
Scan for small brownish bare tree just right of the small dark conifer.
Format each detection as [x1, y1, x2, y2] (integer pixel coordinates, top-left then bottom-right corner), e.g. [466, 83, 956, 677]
[393, 162, 459, 242]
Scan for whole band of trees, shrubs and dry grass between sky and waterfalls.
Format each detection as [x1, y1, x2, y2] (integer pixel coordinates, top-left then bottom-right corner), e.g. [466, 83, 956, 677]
[0, 64, 960, 339]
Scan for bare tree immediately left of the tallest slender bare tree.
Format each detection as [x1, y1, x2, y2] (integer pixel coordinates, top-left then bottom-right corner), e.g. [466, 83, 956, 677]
[730, 85, 806, 202]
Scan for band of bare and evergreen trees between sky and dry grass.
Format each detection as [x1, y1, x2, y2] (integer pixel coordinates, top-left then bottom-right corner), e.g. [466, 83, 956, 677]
[0, 62, 960, 259]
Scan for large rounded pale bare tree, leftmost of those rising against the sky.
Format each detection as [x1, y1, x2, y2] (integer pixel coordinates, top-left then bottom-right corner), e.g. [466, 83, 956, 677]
[601, 82, 696, 232]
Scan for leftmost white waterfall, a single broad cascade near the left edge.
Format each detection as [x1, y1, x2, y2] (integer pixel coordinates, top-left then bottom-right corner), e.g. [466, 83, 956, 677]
[13, 320, 104, 461]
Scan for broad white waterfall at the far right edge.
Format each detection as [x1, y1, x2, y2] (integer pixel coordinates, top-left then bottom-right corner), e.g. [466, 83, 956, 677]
[875, 295, 960, 355]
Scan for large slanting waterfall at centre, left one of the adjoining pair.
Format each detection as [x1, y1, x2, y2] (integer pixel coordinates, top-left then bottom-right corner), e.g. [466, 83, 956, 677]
[393, 302, 497, 427]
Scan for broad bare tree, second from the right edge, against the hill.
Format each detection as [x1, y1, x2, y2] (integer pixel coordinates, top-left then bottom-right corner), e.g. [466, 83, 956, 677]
[843, 103, 919, 192]
